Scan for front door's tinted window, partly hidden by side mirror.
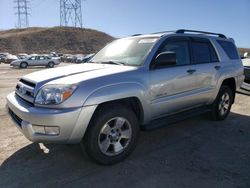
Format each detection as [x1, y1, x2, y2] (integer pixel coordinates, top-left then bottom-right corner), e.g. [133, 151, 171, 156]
[160, 41, 190, 65]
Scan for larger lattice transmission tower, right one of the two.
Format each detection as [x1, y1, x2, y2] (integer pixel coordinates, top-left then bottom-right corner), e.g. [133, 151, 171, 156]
[60, 0, 82, 28]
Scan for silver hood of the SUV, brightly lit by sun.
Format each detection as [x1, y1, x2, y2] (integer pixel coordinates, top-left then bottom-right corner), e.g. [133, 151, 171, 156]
[23, 63, 137, 84]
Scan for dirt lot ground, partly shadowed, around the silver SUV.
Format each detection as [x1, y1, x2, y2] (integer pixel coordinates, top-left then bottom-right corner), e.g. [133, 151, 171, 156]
[0, 64, 250, 188]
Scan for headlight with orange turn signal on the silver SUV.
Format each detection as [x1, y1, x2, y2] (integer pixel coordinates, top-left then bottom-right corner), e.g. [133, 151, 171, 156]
[35, 85, 77, 105]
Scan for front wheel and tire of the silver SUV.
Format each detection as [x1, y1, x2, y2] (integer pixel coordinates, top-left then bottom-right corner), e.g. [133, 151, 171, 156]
[81, 104, 139, 165]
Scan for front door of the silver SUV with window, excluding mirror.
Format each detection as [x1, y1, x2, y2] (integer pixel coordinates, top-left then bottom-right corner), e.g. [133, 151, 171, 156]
[150, 37, 199, 118]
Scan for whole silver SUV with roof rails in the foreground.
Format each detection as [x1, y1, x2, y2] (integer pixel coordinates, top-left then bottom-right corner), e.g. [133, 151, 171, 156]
[7, 30, 244, 164]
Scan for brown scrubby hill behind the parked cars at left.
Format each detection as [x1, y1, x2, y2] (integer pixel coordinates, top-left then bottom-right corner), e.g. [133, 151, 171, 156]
[0, 27, 114, 54]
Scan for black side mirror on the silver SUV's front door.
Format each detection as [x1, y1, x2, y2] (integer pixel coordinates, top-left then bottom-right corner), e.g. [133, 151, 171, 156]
[153, 51, 176, 68]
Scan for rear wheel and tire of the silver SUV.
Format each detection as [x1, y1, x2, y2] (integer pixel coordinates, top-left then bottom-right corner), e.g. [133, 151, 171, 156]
[211, 85, 233, 121]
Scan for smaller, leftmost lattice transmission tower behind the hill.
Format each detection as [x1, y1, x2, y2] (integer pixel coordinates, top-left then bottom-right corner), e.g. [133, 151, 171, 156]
[14, 0, 30, 28]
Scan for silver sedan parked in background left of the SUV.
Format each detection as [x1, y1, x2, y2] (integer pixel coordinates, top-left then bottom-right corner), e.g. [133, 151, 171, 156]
[10, 55, 60, 68]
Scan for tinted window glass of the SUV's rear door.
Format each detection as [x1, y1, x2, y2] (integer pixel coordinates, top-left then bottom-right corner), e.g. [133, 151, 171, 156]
[192, 42, 210, 63]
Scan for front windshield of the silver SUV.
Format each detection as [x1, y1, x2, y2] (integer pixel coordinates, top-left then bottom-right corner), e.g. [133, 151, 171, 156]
[91, 37, 158, 66]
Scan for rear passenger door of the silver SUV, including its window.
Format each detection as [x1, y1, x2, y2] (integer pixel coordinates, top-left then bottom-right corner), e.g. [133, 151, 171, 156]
[191, 37, 221, 104]
